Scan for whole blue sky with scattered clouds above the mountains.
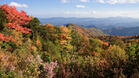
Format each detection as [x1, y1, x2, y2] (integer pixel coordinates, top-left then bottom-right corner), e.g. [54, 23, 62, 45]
[0, 0, 139, 18]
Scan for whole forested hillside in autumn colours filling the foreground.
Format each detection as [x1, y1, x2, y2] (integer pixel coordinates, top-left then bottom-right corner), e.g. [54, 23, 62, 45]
[0, 4, 139, 78]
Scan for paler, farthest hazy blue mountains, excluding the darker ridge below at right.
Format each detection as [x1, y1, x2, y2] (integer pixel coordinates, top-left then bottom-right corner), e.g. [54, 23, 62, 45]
[40, 17, 139, 29]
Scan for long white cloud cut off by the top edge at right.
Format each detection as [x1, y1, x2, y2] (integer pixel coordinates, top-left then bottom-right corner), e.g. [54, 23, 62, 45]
[97, 0, 139, 4]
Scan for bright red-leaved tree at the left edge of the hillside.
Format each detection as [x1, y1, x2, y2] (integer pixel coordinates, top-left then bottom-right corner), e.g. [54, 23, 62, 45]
[0, 4, 31, 33]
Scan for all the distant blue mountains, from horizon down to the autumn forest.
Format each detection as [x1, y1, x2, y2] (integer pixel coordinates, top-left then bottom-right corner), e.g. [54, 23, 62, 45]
[39, 17, 139, 36]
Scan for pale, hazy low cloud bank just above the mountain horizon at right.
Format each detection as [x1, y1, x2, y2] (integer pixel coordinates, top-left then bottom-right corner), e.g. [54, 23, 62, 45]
[64, 10, 139, 18]
